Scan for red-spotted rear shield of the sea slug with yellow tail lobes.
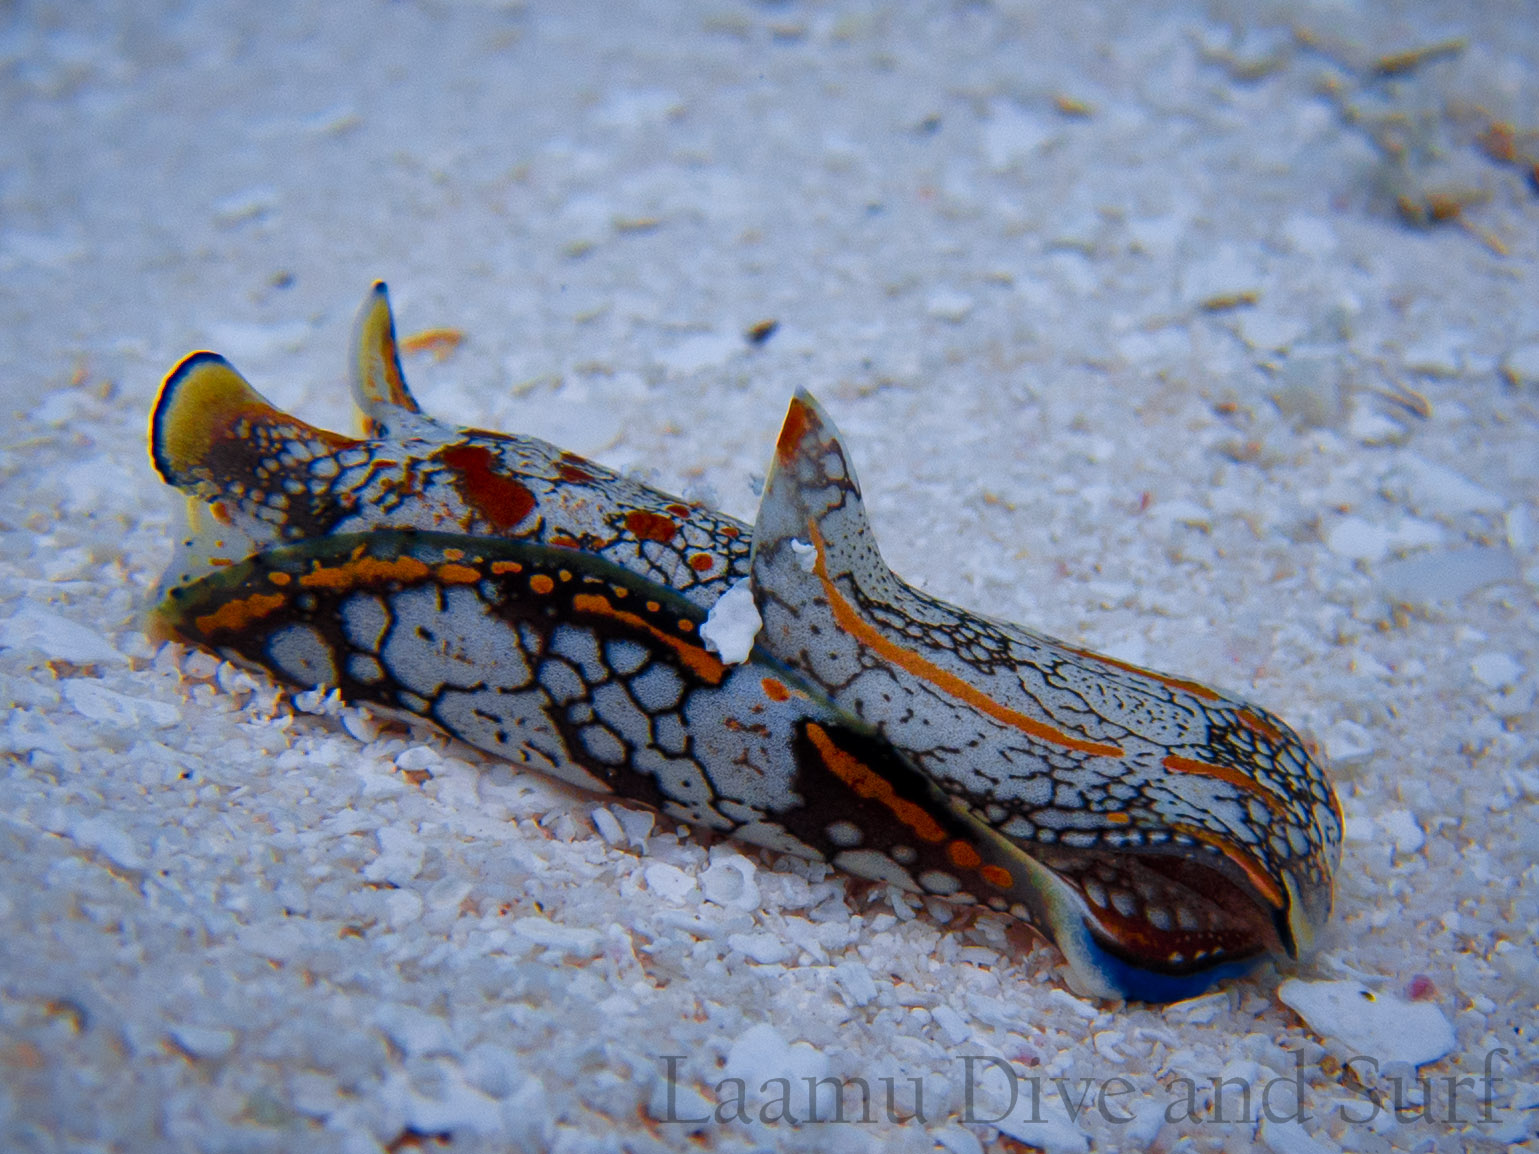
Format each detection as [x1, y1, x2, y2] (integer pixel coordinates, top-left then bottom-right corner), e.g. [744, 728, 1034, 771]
[149, 285, 748, 609]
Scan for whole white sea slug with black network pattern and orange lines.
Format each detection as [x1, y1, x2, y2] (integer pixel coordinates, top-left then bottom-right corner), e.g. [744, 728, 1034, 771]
[151, 285, 1340, 1002]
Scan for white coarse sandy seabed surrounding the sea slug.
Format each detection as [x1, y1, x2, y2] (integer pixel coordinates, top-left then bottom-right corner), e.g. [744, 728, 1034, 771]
[0, 0, 1539, 1154]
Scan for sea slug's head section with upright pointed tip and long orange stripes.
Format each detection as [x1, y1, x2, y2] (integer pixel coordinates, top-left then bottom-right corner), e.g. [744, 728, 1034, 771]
[753, 392, 1342, 992]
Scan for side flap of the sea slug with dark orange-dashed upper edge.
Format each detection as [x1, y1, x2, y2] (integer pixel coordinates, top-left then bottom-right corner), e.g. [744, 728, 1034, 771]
[160, 529, 1151, 966]
